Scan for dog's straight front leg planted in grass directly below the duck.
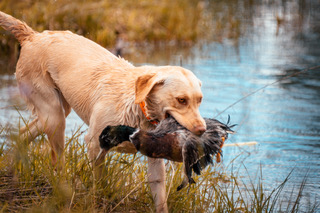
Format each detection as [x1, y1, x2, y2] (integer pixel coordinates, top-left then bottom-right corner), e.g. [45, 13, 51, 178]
[148, 158, 168, 213]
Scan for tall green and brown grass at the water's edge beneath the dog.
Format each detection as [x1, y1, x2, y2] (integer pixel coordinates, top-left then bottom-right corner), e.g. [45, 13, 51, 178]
[0, 117, 319, 212]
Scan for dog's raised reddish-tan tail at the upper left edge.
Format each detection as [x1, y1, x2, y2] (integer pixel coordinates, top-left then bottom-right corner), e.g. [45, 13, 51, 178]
[0, 11, 36, 44]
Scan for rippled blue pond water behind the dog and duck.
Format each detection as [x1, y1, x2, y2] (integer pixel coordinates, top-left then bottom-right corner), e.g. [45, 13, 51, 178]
[0, 1, 320, 210]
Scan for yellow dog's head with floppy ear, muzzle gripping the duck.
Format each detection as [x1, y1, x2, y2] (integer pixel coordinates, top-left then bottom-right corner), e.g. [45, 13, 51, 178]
[135, 66, 206, 135]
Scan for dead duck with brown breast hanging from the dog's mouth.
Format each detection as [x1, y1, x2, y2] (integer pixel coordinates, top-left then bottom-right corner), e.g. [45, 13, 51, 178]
[99, 117, 235, 190]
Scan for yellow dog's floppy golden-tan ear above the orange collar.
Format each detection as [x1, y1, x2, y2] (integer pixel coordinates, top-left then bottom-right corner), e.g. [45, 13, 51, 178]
[135, 73, 164, 104]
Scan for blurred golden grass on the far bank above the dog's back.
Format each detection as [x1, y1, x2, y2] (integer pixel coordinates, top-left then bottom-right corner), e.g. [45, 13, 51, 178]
[0, 0, 204, 43]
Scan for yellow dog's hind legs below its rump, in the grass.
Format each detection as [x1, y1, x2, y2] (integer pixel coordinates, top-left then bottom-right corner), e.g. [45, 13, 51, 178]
[18, 81, 70, 167]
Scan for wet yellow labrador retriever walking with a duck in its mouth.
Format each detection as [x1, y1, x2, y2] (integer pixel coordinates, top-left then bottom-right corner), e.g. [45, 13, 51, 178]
[0, 12, 206, 212]
